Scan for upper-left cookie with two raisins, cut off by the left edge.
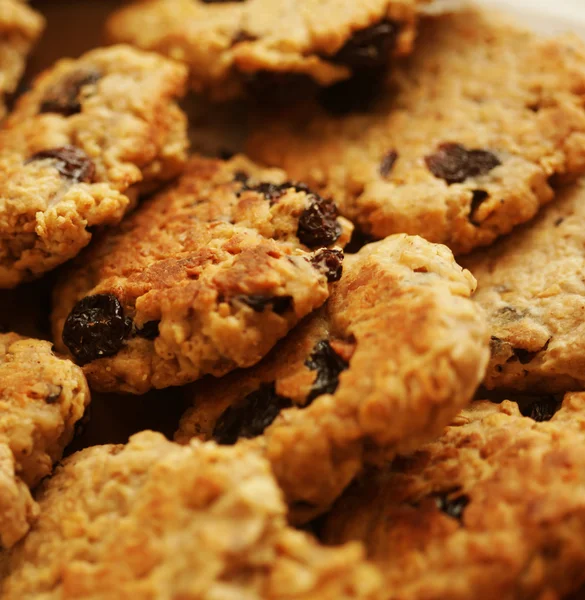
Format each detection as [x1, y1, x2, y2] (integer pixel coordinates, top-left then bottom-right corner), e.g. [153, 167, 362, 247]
[0, 46, 187, 287]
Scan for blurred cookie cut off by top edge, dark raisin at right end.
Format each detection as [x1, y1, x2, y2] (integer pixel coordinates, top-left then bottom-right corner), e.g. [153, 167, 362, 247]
[108, 0, 417, 98]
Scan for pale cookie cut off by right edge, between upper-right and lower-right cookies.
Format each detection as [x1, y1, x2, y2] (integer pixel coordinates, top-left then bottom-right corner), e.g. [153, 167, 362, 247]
[465, 182, 585, 392]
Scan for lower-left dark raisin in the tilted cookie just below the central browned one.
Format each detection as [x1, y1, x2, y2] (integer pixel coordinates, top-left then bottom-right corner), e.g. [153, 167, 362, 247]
[213, 383, 292, 445]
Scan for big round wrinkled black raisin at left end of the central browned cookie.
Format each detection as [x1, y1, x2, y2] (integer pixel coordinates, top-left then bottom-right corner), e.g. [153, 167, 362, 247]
[63, 294, 130, 364]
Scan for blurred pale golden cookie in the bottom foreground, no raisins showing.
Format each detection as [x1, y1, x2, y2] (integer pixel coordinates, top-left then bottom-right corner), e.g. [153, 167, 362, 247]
[2, 431, 382, 600]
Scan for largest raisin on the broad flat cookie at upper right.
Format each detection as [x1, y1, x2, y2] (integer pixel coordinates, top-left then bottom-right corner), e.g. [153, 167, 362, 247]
[425, 143, 502, 185]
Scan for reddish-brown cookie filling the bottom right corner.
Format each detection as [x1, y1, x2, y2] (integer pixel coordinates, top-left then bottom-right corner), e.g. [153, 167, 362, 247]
[324, 394, 585, 600]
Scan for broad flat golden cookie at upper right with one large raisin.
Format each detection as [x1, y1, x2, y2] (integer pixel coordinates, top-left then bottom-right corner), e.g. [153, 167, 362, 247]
[248, 11, 585, 254]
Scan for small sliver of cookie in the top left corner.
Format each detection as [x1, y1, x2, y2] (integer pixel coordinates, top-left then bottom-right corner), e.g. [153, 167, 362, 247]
[0, 0, 45, 119]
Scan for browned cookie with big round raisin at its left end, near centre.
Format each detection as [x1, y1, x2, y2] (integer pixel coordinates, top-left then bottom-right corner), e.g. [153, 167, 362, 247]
[53, 157, 351, 393]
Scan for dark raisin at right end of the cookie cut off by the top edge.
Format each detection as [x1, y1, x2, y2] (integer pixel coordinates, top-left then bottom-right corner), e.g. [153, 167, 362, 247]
[330, 20, 400, 70]
